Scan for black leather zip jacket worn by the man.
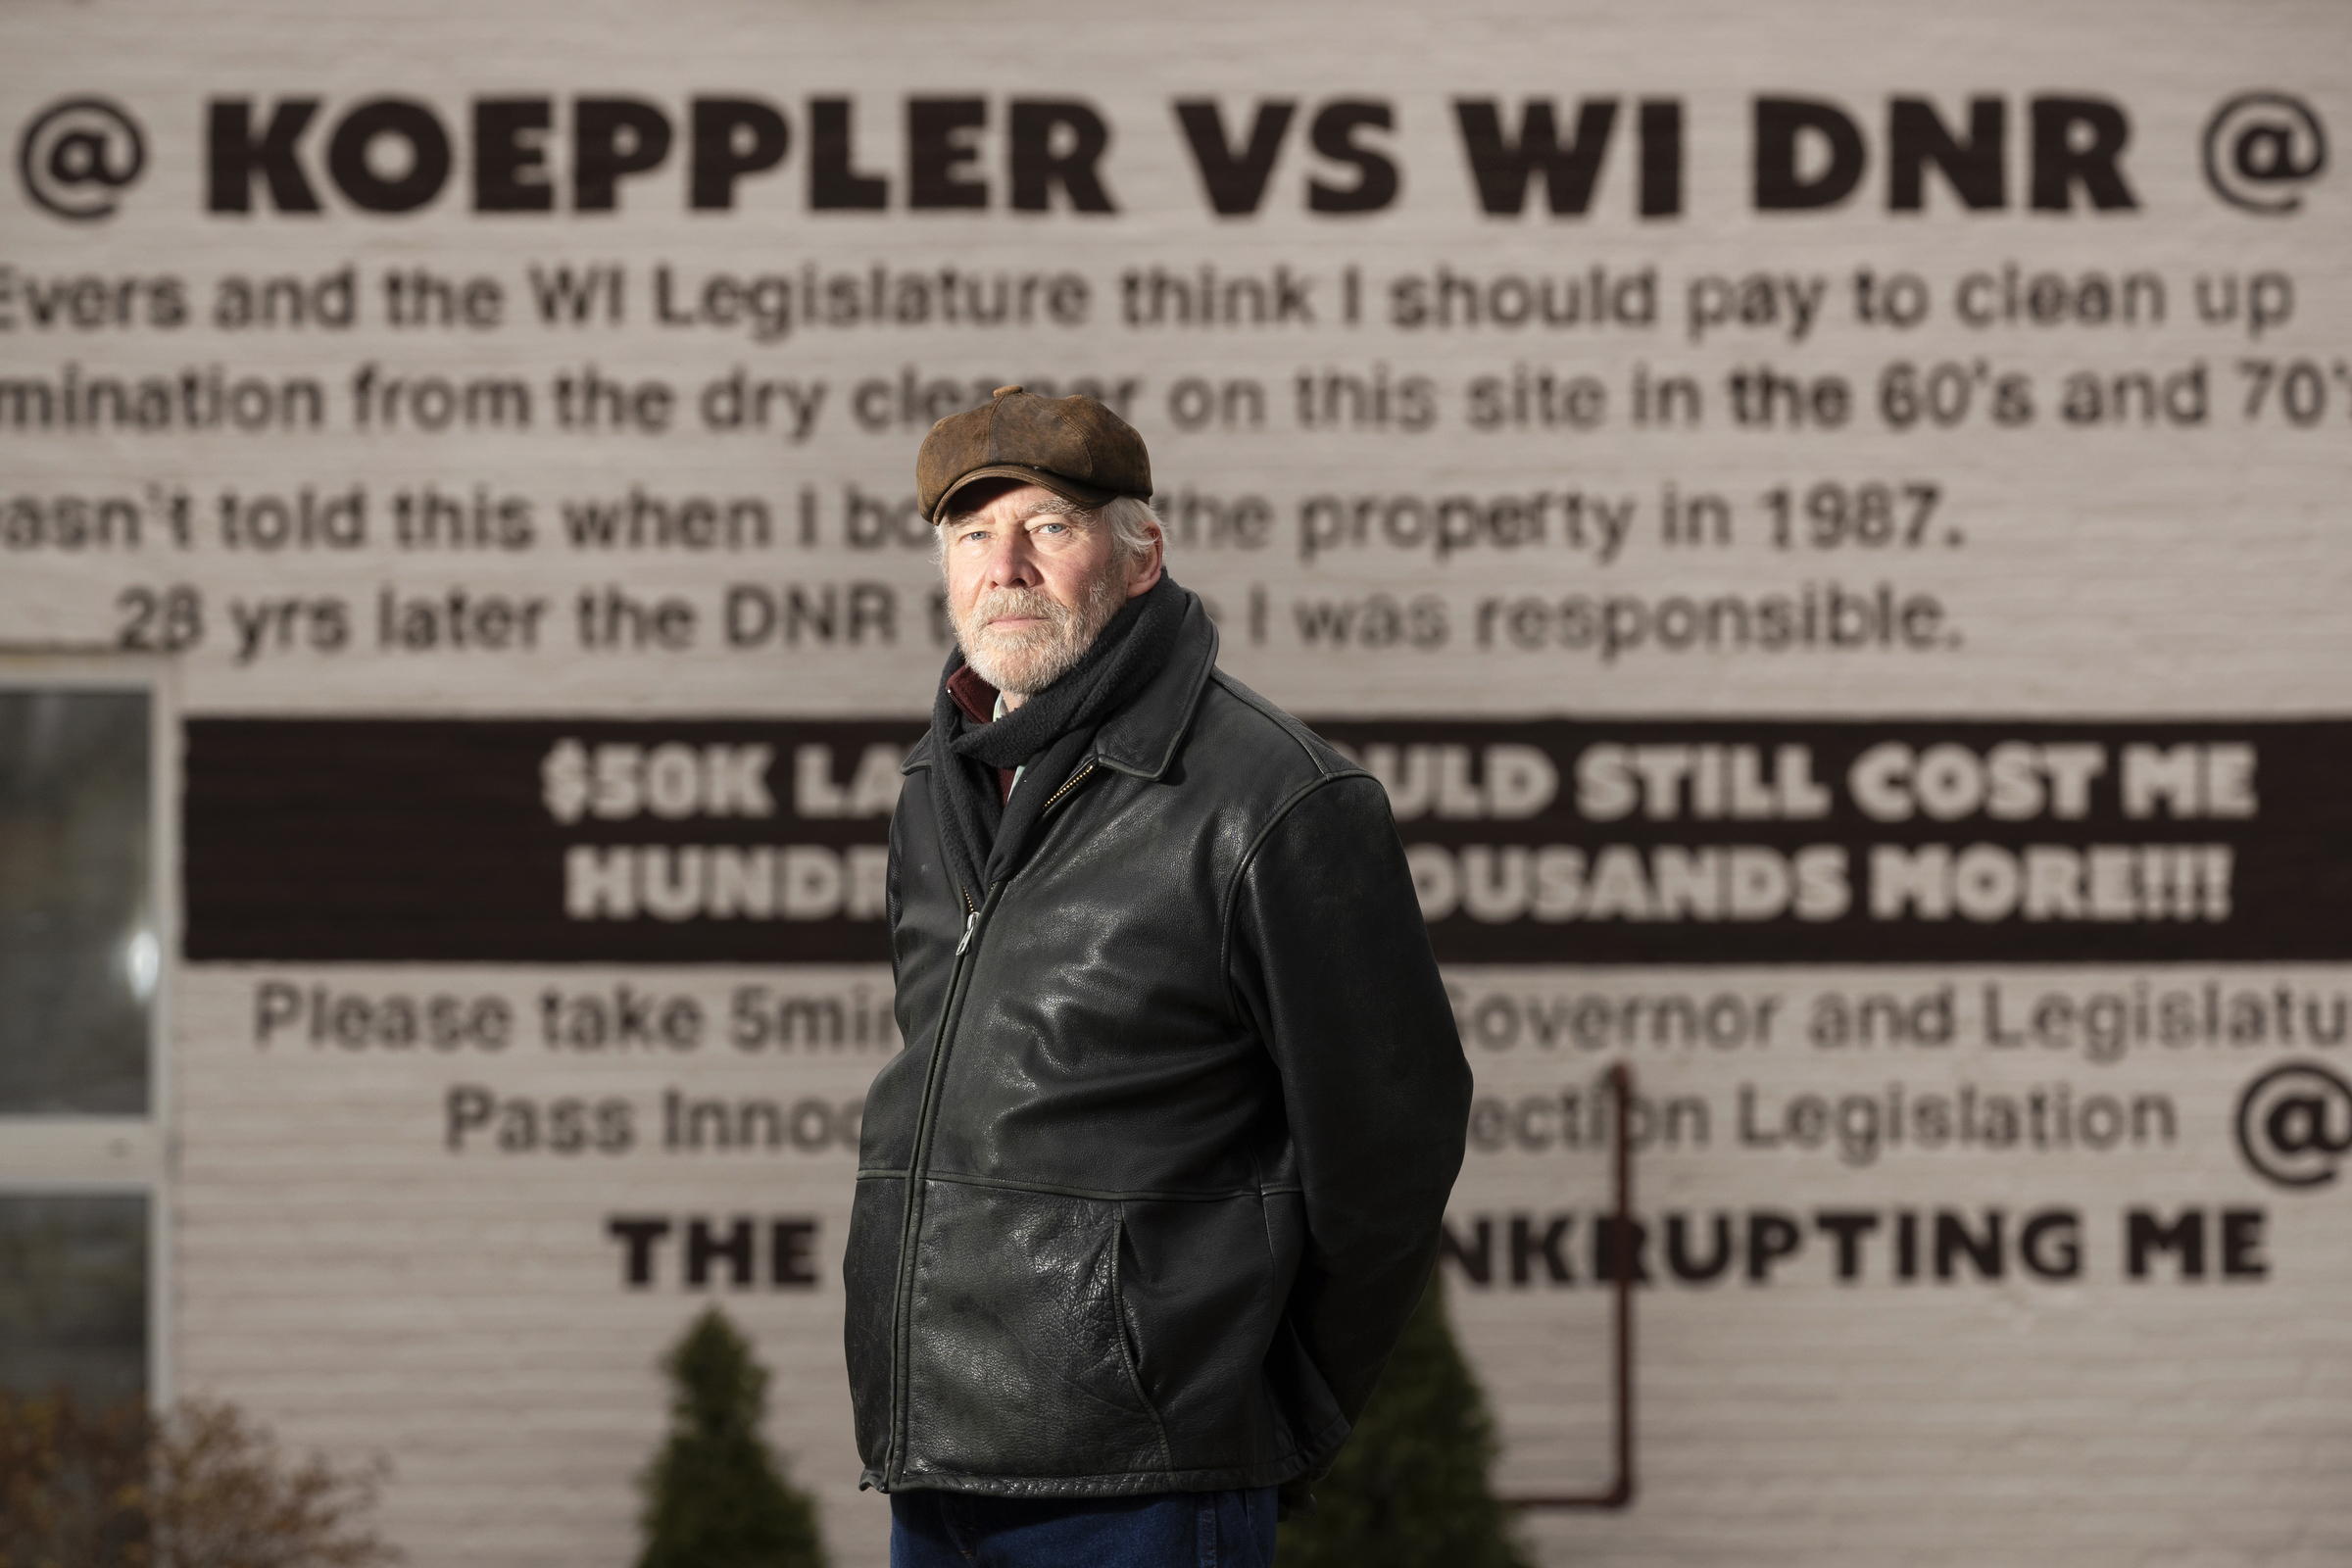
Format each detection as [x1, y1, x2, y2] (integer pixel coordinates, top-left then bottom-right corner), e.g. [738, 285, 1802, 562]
[845, 600, 1470, 1497]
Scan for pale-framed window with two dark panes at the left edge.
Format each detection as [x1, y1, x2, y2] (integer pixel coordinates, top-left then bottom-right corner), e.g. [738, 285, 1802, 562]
[0, 661, 170, 1405]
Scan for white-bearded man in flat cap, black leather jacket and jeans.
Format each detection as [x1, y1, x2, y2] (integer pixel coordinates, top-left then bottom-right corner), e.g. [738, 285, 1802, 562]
[845, 385, 1470, 1568]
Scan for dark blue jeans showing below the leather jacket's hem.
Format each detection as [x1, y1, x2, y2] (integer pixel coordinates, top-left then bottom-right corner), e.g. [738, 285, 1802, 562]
[889, 1486, 1275, 1568]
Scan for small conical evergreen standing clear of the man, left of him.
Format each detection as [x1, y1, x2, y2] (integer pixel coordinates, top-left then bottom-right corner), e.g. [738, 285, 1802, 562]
[637, 1307, 825, 1568]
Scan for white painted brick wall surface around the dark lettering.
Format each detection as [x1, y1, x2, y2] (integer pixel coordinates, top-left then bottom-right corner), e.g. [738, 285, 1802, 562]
[0, 0, 2352, 1568]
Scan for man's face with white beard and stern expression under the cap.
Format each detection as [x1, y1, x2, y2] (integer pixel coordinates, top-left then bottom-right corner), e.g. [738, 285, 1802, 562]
[943, 484, 1159, 708]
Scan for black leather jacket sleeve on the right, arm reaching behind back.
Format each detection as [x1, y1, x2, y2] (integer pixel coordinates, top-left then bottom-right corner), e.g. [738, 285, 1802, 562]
[1230, 773, 1470, 1425]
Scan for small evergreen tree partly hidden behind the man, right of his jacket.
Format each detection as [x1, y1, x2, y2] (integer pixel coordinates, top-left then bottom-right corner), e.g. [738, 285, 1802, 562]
[1275, 1272, 1529, 1568]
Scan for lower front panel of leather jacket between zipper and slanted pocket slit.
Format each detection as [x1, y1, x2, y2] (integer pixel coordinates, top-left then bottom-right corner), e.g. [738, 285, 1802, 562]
[906, 1180, 1169, 1479]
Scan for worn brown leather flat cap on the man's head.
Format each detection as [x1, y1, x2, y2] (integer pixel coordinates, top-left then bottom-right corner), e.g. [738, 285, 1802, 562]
[915, 385, 1152, 522]
